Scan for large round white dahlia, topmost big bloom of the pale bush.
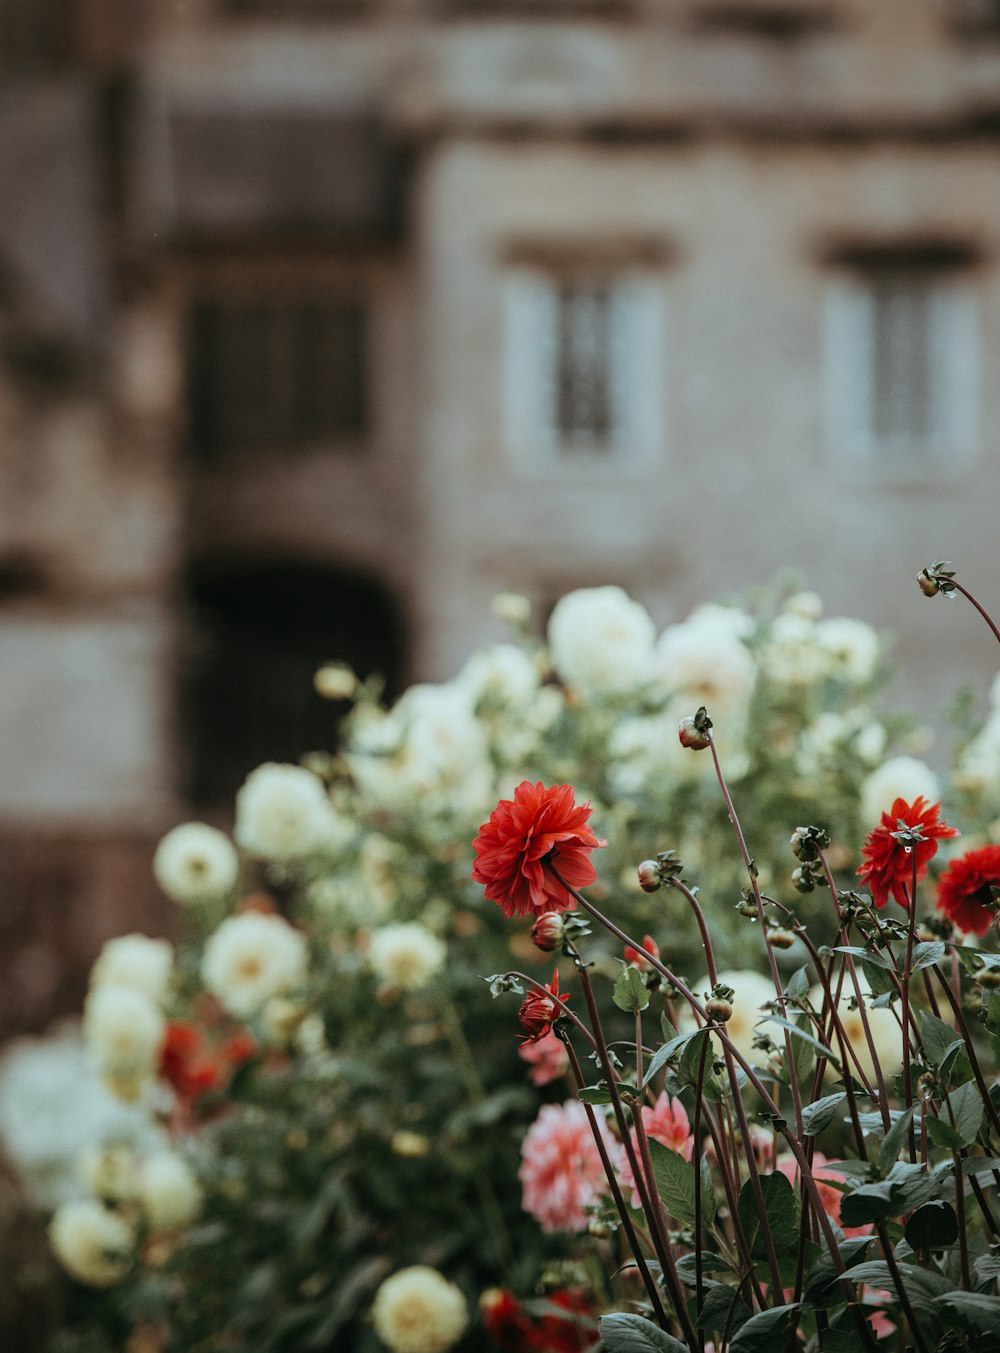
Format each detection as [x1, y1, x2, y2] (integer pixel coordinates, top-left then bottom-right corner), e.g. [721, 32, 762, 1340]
[548, 587, 656, 694]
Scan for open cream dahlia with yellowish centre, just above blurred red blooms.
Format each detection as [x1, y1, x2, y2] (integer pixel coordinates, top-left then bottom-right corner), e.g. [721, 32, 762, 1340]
[202, 912, 306, 1019]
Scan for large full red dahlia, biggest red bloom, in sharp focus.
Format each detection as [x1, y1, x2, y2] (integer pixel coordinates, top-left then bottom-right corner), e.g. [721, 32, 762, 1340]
[472, 779, 608, 916]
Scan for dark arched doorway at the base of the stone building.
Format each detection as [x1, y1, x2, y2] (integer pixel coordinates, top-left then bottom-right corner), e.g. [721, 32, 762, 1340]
[183, 559, 405, 810]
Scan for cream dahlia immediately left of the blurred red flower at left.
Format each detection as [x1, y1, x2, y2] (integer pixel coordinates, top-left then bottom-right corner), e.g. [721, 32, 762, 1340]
[84, 985, 166, 1100]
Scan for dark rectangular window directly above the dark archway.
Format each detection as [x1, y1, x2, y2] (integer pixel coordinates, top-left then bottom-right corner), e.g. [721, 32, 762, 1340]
[188, 296, 367, 464]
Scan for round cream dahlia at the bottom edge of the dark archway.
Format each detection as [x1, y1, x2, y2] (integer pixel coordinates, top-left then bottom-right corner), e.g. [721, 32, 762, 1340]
[235, 762, 336, 859]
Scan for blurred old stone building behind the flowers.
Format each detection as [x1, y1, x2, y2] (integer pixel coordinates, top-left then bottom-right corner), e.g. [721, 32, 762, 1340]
[0, 0, 1000, 1031]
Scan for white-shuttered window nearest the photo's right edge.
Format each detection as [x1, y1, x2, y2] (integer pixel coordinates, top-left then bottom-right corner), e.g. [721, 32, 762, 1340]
[827, 254, 977, 478]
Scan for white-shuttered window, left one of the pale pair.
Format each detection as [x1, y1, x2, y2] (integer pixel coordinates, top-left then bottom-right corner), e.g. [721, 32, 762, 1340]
[506, 267, 663, 465]
